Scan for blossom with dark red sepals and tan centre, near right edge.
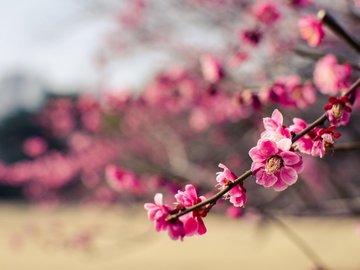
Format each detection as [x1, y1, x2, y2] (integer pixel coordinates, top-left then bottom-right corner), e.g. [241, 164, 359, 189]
[324, 96, 351, 127]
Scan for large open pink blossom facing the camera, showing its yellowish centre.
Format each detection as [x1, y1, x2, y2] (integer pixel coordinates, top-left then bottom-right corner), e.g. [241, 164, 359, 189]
[249, 139, 303, 191]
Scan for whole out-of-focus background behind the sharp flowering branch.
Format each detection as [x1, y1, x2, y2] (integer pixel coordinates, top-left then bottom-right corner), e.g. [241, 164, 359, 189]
[0, 0, 360, 270]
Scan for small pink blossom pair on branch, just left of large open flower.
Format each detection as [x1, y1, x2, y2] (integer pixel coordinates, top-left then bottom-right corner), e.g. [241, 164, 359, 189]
[216, 163, 247, 207]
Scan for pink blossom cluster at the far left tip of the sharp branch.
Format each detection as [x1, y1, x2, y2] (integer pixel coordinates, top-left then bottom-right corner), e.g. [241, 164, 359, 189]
[144, 193, 185, 240]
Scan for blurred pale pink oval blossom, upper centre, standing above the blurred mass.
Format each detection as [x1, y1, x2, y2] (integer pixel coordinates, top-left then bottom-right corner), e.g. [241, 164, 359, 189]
[200, 55, 223, 83]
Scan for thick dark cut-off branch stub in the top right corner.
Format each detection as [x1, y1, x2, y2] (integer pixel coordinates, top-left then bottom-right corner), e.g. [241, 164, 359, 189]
[317, 9, 360, 53]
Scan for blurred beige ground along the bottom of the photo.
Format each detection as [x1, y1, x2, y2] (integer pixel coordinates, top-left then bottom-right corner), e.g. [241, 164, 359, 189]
[0, 205, 360, 270]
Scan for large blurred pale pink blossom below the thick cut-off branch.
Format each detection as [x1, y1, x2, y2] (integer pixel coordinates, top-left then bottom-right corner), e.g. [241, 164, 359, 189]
[314, 54, 352, 95]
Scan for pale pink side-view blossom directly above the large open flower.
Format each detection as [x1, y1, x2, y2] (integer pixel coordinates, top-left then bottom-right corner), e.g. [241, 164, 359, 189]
[261, 109, 291, 150]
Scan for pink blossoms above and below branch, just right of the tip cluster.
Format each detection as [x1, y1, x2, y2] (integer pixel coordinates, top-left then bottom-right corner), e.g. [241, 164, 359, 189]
[175, 184, 207, 236]
